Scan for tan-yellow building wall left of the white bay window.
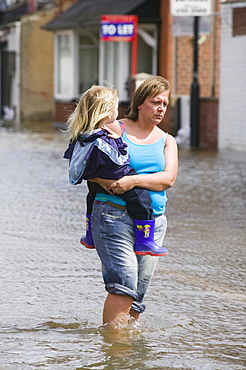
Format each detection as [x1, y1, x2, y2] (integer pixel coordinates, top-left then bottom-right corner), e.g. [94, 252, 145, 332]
[20, 10, 53, 121]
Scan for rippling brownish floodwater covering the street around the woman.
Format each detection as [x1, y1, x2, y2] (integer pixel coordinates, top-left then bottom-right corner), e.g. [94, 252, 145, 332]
[0, 122, 246, 370]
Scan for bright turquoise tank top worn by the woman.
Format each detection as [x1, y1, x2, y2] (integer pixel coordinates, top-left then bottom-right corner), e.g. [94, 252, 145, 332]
[96, 127, 167, 216]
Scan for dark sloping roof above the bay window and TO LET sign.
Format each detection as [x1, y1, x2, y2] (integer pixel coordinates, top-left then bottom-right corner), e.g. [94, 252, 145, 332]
[42, 0, 160, 31]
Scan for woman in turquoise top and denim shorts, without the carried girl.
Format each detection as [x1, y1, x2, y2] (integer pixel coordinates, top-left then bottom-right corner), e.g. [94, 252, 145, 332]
[64, 76, 178, 326]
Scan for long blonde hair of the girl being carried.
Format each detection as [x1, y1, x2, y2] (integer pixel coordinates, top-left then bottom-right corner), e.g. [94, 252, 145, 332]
[66, 85, 118, 140]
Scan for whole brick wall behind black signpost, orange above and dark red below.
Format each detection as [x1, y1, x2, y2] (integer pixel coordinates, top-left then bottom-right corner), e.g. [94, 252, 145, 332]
[158, 0, 220, 147]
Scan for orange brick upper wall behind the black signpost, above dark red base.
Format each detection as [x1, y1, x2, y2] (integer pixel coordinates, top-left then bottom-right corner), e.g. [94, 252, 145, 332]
[158, 0, 220, 101]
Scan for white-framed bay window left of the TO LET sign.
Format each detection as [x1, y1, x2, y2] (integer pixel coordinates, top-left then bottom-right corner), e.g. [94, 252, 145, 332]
[54, 29, 99, 101]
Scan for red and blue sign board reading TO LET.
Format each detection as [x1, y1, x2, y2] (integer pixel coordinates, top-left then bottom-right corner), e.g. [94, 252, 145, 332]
[101, 15, 138, 41]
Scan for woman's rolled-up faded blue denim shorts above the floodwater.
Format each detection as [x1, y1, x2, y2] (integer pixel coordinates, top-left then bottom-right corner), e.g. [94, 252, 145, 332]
[91, 201, 167, 313]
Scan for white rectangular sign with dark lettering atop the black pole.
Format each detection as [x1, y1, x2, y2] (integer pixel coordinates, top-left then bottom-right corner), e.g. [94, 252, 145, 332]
[171, 0, 211, 17]
